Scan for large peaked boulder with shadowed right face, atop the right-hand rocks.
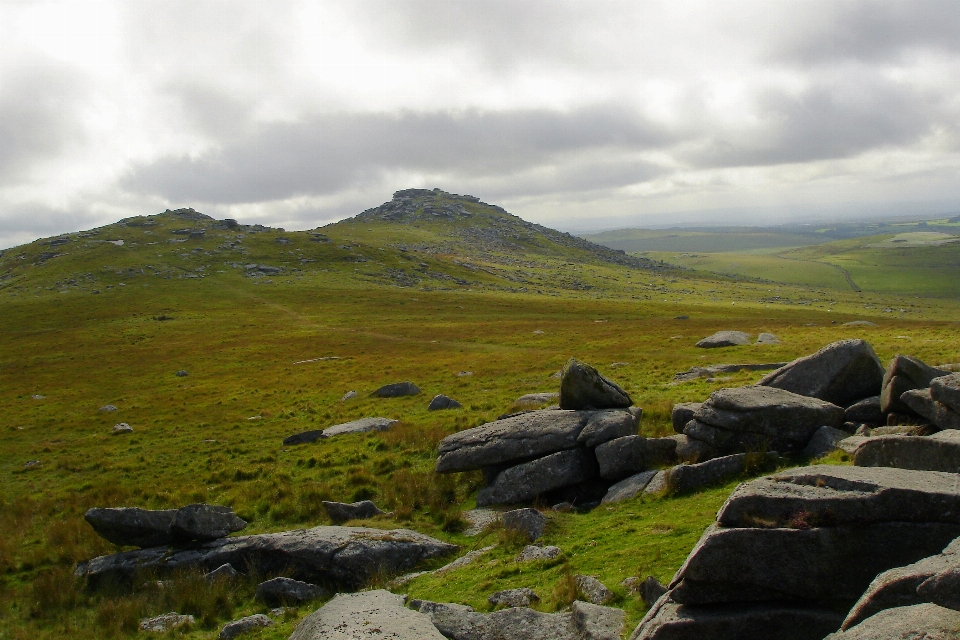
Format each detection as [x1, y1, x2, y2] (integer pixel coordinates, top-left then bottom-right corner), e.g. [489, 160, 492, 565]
[757, 340, 883, 408]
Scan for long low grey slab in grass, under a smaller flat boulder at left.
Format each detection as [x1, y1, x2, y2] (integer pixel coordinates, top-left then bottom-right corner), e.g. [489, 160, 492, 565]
[74, 527, 457, 588]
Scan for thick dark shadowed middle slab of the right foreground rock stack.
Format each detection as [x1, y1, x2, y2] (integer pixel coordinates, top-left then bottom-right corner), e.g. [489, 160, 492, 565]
[670, 522, 960, 605]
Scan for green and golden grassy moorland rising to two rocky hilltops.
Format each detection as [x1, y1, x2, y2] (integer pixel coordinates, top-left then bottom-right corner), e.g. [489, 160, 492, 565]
[0, 190, 960, 638]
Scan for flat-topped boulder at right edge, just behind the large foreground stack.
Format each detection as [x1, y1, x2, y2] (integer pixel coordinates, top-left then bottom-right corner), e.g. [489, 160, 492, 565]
[853, 430, 960, 473]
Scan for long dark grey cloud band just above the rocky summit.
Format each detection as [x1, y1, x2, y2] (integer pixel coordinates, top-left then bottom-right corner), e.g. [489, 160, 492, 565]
[125, 107, 671, 202]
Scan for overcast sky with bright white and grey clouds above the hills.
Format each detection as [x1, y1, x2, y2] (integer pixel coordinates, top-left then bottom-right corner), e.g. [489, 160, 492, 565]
[0, 0, 960, 248]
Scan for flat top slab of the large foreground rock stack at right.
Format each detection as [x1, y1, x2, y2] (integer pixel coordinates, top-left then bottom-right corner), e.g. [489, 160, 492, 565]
[717, 465, 960, 527]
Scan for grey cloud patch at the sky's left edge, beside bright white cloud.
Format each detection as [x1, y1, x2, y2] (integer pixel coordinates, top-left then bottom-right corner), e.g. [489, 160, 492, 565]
[0, 61, 87, 185]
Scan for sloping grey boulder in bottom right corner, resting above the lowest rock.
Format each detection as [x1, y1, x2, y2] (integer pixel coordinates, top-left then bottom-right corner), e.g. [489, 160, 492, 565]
[840, 540, 960, 629]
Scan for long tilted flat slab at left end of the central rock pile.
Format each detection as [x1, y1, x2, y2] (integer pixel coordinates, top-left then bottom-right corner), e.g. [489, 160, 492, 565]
[436, 409, 590, 473]
